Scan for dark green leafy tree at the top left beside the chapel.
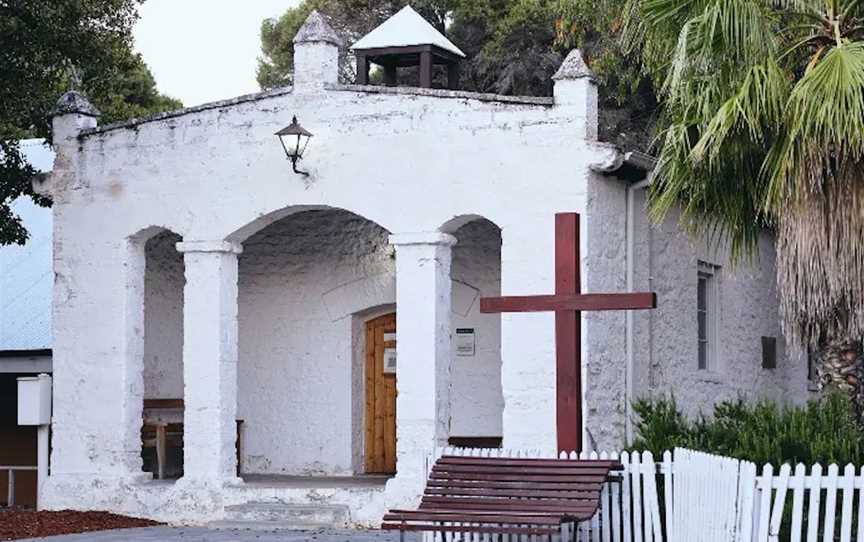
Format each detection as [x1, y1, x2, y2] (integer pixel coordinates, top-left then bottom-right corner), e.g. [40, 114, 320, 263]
[0, 0, 181, 245]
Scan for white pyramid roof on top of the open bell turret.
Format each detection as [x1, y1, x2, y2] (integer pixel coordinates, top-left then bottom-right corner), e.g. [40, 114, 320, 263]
[351, 6, 465, 58]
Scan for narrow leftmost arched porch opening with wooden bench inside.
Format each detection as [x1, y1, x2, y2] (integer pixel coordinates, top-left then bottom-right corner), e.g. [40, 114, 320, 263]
[141, 230, 186, 479]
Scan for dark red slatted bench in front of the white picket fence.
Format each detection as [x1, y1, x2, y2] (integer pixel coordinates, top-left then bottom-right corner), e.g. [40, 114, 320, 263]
[381, 456, 622, 537]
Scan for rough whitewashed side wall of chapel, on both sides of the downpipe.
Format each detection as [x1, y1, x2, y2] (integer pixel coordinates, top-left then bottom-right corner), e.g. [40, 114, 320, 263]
[583, 180, 809, 449]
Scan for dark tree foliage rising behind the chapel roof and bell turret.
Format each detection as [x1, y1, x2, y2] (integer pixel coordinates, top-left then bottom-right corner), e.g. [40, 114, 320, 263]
[258, 0, 656, 148]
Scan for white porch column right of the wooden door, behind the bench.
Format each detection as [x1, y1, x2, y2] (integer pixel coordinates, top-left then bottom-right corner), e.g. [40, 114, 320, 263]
[390, 232, 456, 478]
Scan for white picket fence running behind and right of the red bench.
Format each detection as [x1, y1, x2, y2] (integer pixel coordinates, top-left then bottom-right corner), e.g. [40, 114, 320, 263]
[428, 448, 864, 542]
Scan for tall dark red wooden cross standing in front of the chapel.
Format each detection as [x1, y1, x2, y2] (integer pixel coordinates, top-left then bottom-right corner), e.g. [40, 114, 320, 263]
[480, 213, 657, 452]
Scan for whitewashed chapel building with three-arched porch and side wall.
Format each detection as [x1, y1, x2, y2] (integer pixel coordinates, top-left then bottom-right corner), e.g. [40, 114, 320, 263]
[37, 8, 808, 525]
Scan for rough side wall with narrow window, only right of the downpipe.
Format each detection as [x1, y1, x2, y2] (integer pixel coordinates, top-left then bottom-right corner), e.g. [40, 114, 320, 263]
[634, 190, 811, 415]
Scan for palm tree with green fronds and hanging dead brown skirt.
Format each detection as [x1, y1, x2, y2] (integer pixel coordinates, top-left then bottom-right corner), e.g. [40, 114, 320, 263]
[628, 0, 864, 416]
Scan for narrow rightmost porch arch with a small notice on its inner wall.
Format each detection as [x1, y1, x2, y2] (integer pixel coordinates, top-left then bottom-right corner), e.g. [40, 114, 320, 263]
[443, 216, 504, 448]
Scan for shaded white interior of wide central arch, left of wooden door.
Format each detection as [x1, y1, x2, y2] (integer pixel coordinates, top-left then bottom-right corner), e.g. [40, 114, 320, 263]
[237, 209, 395, 481]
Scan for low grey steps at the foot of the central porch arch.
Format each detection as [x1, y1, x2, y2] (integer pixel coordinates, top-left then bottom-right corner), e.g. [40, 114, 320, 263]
[210, 502, 350, 530]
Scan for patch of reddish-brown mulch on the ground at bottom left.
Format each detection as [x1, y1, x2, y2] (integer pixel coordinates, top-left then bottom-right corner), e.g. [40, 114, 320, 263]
[0, 510, 158, 540]
